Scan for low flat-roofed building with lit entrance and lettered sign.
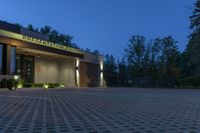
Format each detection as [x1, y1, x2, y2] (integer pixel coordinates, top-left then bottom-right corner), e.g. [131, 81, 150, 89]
[0, 21, 103, 87]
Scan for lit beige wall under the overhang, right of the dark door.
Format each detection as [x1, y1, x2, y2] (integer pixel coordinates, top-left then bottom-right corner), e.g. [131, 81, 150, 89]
[34, 57, 75, 87]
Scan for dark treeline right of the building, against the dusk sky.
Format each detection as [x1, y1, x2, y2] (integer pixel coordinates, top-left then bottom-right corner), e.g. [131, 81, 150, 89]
[104, 1, 200, 87]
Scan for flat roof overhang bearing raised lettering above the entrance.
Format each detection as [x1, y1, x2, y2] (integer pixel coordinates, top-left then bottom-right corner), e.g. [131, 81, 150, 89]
[0, 29, 84, 59]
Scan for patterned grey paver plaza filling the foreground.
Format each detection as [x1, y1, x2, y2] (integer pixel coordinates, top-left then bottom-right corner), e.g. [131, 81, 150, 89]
[0, 88, 200, 133]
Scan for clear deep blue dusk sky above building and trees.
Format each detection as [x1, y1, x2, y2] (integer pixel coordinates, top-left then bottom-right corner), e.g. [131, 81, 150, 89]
[0, 0, 195, 58]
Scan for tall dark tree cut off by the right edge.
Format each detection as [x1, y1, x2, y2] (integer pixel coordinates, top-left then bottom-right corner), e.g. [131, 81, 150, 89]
[185, 0, 200, 86]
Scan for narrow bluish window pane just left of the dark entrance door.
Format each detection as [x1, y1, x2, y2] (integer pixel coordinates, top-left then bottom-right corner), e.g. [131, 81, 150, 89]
[10, 47, 16, 75]
